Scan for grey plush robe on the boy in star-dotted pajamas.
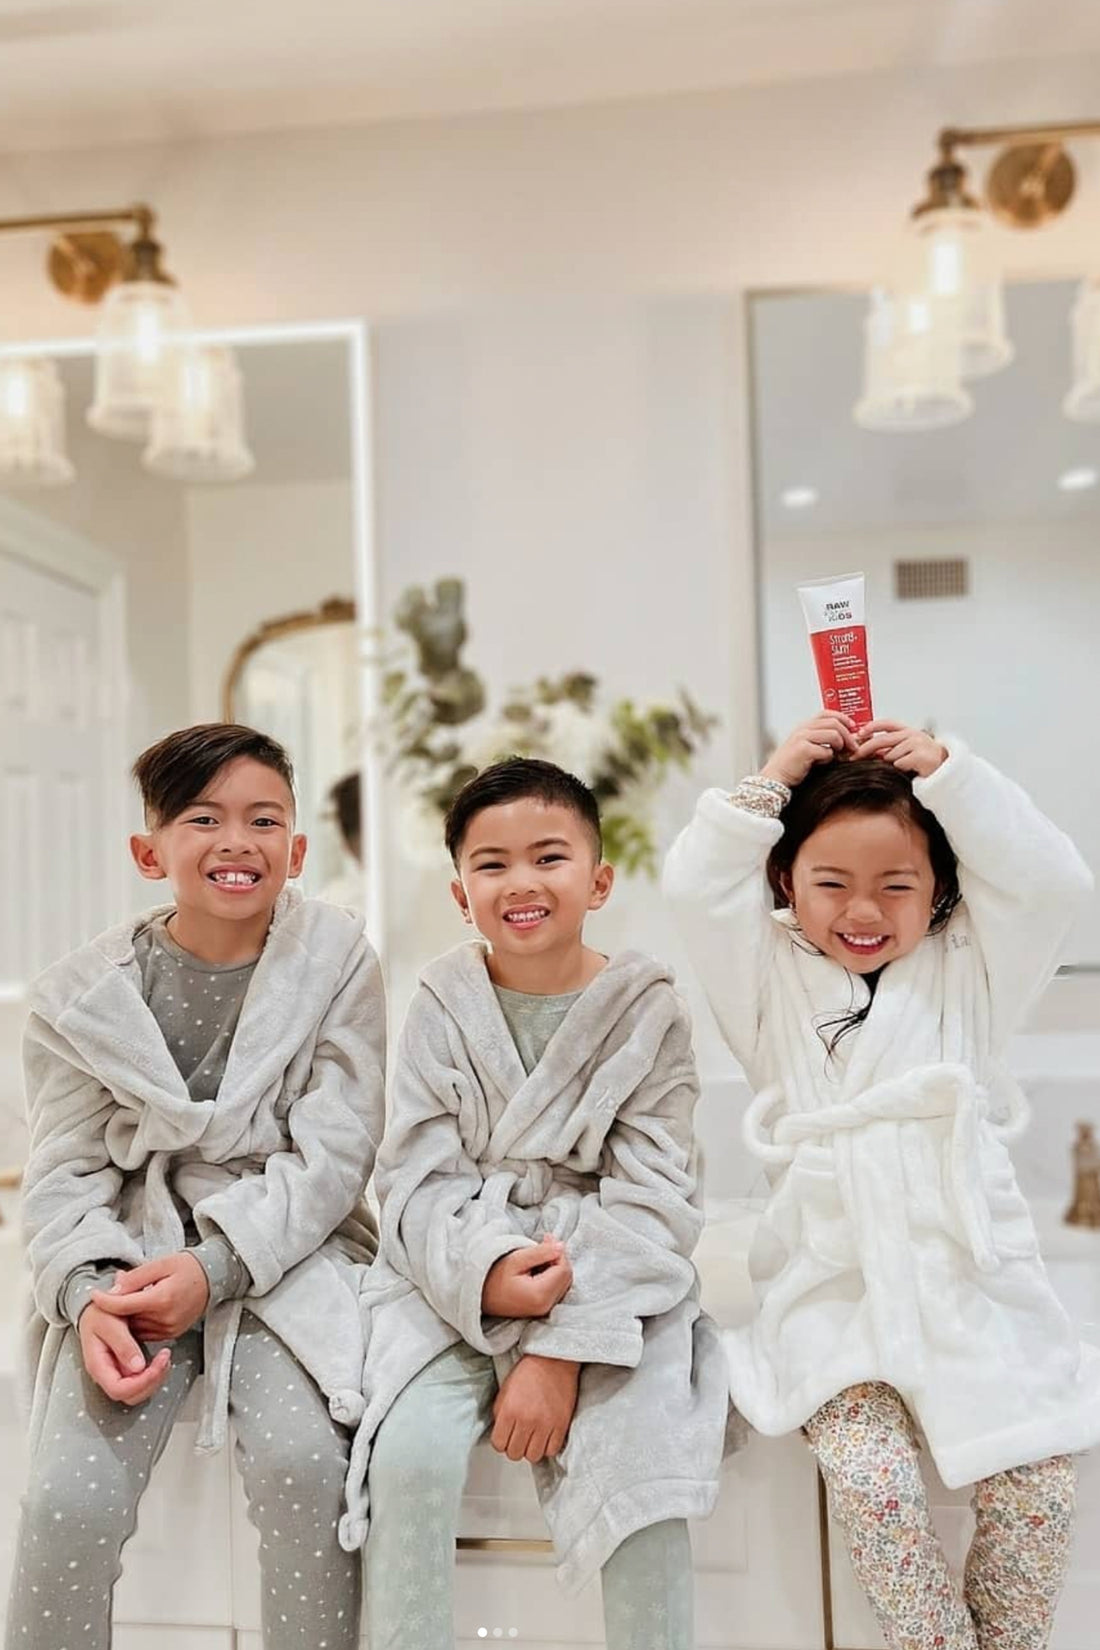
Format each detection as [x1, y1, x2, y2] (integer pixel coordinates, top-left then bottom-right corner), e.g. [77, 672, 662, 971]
[23, 889, 386, 1449]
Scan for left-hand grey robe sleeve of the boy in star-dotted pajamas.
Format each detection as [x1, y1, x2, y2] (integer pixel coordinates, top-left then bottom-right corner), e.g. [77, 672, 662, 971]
[21, 1013, 145, 1327]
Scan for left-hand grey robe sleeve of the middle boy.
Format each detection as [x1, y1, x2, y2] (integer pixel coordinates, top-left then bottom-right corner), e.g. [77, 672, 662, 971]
[374, 987, 533, 1355]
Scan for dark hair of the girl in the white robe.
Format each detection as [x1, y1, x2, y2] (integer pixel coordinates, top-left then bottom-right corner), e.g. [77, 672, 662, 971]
[767, 757, 961, 1054]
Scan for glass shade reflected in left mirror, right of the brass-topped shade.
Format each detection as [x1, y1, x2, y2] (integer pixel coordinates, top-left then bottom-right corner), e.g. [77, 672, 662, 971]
[142, 345, 256, 482]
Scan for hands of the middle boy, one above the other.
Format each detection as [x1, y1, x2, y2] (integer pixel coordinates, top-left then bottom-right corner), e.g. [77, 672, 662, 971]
[482, 1238, 581, 1462]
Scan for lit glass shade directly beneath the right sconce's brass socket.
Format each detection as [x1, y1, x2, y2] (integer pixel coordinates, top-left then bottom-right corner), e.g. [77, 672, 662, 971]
[905, 206, 1016, 378]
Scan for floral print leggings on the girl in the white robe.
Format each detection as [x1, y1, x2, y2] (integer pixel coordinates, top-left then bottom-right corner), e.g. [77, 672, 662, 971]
[805, 1381, 1077, 1650]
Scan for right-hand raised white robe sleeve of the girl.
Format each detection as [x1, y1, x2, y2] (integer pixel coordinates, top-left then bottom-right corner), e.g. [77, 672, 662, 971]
[914, 741, 1093, 1049]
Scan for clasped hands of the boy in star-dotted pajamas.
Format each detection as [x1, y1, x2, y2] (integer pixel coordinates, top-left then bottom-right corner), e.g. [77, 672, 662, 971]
[78, 1252, 209, 1404]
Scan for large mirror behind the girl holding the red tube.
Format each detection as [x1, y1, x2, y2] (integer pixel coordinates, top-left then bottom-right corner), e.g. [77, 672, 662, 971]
[749, 281, 1100, 972]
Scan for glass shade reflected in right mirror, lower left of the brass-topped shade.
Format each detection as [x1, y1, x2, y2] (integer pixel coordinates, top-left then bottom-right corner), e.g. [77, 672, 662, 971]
[853, 289, 973, 431]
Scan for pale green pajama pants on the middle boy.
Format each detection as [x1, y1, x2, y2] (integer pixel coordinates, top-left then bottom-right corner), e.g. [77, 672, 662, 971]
[366, 1345, 694, 1650]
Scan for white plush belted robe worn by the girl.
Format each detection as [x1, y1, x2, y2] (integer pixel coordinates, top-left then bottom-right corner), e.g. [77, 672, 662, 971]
[665, 744, 1100, 1487]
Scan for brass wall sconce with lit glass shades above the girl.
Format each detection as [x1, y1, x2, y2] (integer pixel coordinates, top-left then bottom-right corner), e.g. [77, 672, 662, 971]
[854, 120, 1100, 431]
